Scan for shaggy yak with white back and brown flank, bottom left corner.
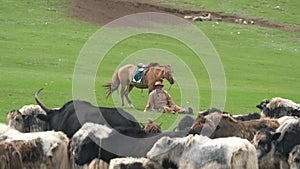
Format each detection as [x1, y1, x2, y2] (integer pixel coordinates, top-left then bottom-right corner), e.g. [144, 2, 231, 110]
[0, 124, 70, 169]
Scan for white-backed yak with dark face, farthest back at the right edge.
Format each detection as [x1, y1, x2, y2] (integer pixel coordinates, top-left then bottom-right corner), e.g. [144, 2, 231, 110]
[256, 97, 300, 118]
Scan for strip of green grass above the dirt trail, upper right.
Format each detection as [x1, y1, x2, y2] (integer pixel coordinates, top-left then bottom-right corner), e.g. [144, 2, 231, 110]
[159, 0, 300, 26]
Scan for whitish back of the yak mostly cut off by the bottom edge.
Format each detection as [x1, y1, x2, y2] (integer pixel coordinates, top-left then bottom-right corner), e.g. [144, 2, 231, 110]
[109, 157, 163, 169]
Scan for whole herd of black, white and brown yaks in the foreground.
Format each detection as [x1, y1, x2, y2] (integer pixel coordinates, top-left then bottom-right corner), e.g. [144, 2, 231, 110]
[0, 89, 300, 169]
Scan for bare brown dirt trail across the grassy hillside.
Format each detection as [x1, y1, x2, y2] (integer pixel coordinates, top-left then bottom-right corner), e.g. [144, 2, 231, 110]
[71, 0, 291, 31]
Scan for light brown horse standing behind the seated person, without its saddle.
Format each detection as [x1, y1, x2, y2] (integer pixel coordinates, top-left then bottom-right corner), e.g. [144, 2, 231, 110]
[103, 63, 174, 107]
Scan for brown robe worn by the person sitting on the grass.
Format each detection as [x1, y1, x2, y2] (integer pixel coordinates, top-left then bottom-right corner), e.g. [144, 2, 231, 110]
[145, 89, 174, 112]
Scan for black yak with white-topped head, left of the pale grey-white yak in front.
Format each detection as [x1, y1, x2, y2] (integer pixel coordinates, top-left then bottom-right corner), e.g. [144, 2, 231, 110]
[70, 123, 187, 165]
